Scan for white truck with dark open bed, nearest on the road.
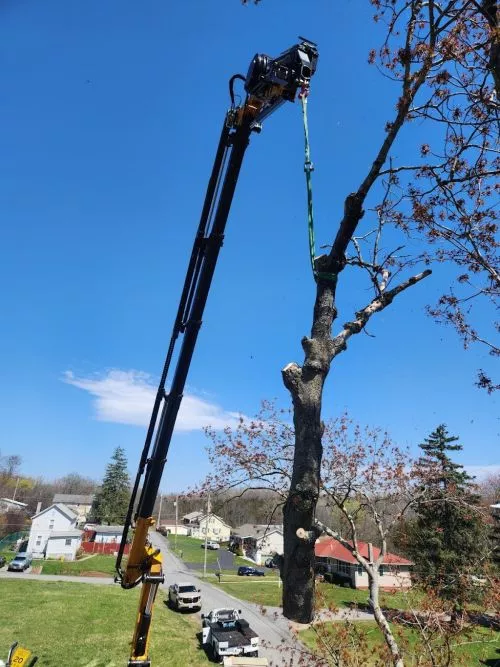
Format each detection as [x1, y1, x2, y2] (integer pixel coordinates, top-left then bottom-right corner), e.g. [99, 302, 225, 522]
[201, 609, 259, 662]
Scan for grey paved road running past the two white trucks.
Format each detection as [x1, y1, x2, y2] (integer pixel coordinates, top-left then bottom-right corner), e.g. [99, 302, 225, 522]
[150, 533, 294, 665]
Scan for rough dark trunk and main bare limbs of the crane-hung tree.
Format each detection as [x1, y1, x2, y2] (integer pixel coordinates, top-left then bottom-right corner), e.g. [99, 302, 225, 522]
[281, 196, 431, 623]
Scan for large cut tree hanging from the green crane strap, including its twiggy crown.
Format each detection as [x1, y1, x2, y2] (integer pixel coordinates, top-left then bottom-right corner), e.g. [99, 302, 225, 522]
[276, 0, 500, 622]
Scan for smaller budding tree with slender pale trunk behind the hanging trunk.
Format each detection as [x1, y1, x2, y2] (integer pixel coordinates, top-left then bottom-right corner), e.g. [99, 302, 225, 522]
[206, 410, 425, 667]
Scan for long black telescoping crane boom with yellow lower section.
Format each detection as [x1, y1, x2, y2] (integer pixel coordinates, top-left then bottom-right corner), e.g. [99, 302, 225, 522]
[116, 37, 318, 667]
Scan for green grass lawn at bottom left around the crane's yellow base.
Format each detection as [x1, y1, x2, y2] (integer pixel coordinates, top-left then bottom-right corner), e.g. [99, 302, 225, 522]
[0, 579, 209, 667]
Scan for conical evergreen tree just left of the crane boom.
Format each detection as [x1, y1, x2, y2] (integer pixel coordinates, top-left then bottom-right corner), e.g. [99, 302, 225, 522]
[91, 447, 130, 525]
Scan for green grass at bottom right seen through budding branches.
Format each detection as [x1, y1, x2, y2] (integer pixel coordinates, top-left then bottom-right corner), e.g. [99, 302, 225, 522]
[299, 621, 500, 667]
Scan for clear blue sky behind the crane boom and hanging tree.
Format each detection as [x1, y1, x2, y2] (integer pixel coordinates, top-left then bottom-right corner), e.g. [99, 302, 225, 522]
[0, 0, 500, 491]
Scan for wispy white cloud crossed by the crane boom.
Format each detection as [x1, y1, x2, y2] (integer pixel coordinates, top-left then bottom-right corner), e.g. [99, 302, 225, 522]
[64, 370, 244, 431]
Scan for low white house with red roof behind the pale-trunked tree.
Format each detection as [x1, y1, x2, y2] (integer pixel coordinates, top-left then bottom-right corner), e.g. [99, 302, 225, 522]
[314, 537, 413, 590]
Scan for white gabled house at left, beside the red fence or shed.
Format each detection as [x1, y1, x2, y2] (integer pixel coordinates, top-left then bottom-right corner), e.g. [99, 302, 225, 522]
[26, 503, 82, 560]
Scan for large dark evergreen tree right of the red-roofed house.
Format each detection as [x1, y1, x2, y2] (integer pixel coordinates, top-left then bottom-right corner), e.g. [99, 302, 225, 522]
[407, 425, 487, 605]
